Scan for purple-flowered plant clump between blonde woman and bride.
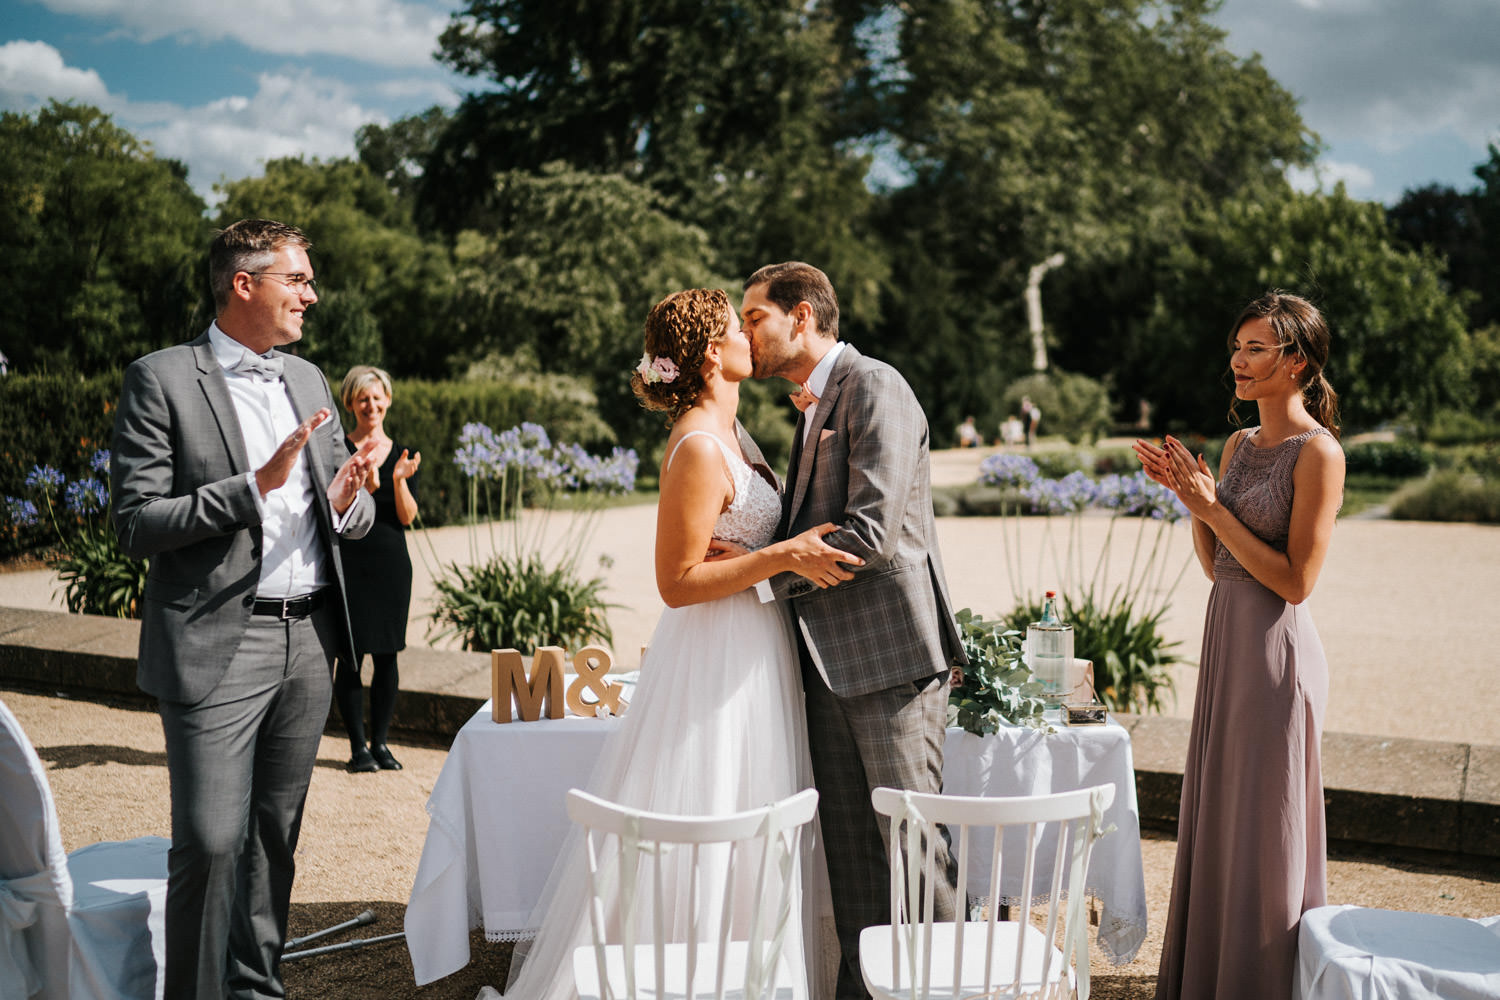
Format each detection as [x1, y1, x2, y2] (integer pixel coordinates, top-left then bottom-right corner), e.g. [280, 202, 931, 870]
[432, 423, 639, 655]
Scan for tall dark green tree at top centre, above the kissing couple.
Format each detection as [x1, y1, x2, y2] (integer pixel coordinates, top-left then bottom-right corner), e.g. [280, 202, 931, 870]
[422, 0, 887, 332]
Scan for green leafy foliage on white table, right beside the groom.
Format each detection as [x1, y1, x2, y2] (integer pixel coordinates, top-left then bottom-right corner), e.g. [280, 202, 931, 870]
[948, 607, 1049, 736]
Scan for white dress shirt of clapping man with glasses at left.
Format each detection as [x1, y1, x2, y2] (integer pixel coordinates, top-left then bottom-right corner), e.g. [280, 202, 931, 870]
[209, 322, 330, 600]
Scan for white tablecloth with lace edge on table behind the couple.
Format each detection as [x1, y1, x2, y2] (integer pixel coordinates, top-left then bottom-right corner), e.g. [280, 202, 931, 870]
[405, 702, 1146, 985]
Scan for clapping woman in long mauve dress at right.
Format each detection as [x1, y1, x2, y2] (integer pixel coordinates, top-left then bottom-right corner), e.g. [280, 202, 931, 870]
[1136, 292, 1344, 1000]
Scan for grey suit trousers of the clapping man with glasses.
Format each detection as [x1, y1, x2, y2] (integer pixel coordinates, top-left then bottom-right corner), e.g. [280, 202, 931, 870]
[159, 606, 338, 1000]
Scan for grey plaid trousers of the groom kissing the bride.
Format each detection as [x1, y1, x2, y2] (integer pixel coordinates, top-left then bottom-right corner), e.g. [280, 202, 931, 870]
[801, 659, 959, 1000]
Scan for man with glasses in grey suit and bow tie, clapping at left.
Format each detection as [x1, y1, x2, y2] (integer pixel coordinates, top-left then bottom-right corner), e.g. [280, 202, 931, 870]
[111, 219, 375, 1000]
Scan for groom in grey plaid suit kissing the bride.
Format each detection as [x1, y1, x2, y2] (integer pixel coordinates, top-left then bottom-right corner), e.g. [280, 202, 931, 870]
[741, 262, 968, 1000]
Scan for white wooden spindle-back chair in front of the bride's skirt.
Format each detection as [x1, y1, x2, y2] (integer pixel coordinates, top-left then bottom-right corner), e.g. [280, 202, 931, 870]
[567, 789, 818, 1000]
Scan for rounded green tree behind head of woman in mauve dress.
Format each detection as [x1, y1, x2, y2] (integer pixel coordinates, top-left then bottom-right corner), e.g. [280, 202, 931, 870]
[1116, 184, 1472, 433]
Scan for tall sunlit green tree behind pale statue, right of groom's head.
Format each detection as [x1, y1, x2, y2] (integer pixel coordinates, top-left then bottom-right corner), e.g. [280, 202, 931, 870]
[875, 0, 1314, 434]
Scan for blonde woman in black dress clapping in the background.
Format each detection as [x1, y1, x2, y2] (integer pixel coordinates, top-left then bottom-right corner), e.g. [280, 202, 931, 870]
[333, 364, 422, 771]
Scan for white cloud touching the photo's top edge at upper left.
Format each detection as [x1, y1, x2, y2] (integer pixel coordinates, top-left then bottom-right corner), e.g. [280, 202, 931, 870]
[30, 0, 449, 66]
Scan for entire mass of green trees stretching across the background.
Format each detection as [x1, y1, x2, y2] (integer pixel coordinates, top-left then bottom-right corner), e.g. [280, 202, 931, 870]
[0, 0, 1500, 445]
